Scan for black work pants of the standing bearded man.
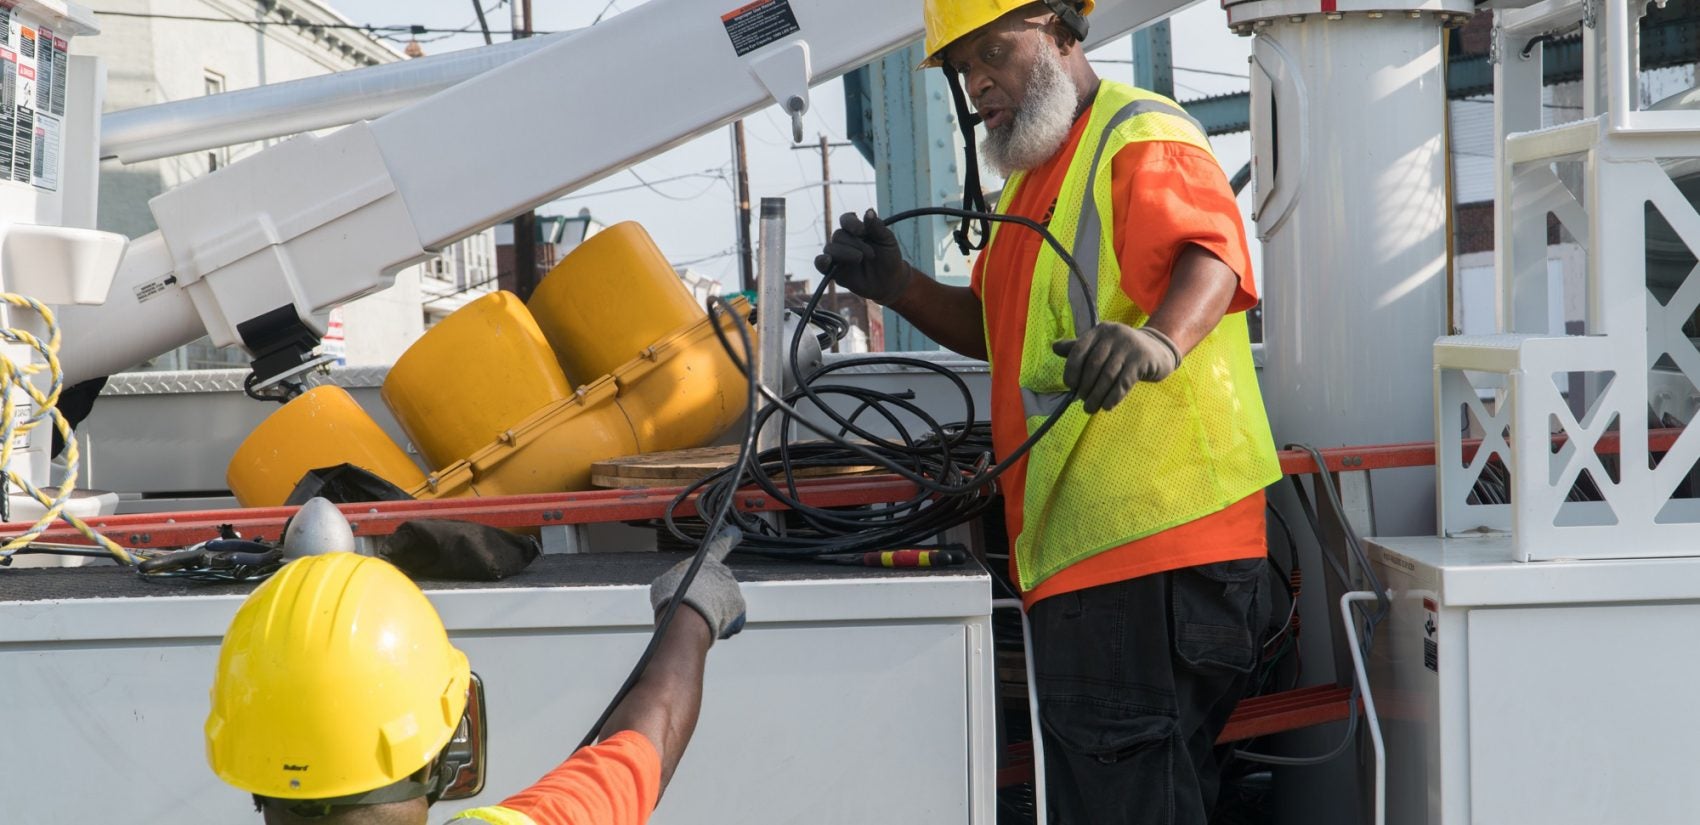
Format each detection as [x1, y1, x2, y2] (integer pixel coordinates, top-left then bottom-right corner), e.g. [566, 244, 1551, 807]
[1029, 558, 1270, 825]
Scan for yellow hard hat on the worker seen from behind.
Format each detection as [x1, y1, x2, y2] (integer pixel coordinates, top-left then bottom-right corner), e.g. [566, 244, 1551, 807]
[206, 553, 471, 799]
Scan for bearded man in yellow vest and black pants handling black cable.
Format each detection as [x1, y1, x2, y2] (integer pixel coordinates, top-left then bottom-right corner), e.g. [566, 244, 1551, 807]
[816, 0, 1280, 825]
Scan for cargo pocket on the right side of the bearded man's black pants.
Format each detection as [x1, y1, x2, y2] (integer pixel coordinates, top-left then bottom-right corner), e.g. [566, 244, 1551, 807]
[1170, 558, 1265, 674]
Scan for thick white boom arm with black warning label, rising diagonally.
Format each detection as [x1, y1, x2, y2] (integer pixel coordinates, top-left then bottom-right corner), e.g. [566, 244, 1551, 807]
[61, 0, 1195, 381]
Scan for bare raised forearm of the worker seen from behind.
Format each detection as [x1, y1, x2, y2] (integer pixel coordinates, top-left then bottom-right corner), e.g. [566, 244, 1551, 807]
[602, 604, 714, 789]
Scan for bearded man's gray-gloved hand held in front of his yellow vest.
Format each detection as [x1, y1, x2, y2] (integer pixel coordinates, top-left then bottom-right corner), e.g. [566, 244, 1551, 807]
[1051, 321, 1180, 415]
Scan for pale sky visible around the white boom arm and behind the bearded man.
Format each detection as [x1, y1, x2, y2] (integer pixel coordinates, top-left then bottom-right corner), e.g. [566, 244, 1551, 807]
[331, 0, 1256, 287]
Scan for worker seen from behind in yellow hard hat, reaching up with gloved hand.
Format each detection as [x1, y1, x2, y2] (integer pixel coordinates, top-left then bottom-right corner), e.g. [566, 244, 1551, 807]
[206, 541, 745, 825]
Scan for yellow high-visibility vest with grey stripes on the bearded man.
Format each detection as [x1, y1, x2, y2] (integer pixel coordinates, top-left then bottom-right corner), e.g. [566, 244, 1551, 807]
[988, 82, 1280, 590]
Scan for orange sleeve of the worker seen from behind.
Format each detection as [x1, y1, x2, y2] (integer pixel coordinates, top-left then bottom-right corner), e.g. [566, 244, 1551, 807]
[502, 730, 661, 825]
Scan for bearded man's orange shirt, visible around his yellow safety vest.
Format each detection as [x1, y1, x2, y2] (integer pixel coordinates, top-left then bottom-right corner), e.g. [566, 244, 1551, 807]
[971, 111, 1268, 607]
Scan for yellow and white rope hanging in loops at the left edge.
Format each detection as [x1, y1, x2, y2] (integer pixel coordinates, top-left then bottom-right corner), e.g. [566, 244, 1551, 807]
[0, 293, 136, 565]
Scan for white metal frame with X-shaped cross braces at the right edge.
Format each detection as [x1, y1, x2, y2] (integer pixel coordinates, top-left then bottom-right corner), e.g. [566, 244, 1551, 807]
[1435, 0, 1700, 561]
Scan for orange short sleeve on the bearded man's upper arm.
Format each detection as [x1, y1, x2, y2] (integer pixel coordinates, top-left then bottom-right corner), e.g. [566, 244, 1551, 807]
[1110, 141, 1258, 315]
